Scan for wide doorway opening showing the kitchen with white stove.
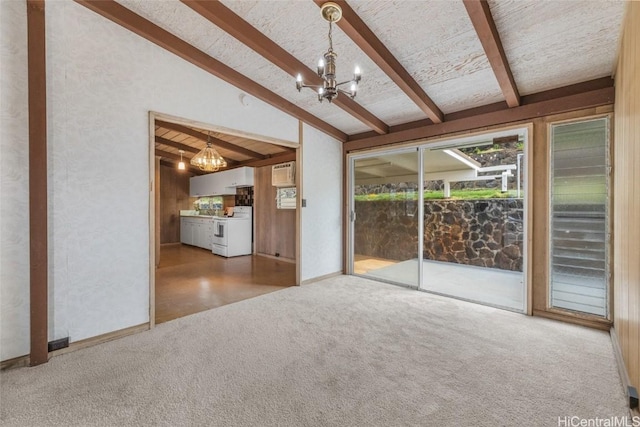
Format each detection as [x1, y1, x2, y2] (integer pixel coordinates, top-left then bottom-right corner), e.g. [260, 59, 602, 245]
[150, 113, 299, 325]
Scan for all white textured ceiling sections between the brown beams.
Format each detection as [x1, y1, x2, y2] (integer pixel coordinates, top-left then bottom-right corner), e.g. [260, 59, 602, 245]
[118, 0, 624, 134]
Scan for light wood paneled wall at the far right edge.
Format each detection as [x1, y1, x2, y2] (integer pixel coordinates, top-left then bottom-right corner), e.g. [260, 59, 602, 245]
[613, 2, 640, 387]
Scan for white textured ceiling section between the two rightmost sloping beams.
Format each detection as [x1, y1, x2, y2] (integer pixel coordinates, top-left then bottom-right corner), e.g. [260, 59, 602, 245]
[349, 0, 503, 113]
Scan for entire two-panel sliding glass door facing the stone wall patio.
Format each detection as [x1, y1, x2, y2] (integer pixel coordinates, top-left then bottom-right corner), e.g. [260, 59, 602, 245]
[349, 128, 529, 312]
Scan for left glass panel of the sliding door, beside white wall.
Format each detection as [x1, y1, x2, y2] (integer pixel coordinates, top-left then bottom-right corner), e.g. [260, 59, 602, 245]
[351, 149, 420, 287]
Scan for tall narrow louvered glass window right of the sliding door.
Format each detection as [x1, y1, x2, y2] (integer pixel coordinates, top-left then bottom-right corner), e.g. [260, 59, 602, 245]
[549, 118, 610, 317]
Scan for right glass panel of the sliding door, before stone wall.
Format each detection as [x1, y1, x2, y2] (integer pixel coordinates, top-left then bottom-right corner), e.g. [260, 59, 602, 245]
[420, 139, 526, 311]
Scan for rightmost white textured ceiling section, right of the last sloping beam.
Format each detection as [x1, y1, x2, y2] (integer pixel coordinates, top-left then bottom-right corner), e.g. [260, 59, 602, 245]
[489, 0, 624, 95]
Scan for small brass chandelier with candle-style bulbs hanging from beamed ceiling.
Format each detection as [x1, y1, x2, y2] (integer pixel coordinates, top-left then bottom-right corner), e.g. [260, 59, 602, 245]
[296, 2, 362, 102]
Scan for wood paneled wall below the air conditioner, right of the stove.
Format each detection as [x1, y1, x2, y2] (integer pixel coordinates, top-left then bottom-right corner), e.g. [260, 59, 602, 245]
[253, 166, 296, 260]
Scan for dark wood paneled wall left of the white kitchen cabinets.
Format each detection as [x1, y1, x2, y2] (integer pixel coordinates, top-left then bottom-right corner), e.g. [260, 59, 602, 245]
[160, 163, 195, 243]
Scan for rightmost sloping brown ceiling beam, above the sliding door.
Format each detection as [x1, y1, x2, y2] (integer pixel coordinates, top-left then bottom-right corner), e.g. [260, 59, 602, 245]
[463, 0, 520, 107]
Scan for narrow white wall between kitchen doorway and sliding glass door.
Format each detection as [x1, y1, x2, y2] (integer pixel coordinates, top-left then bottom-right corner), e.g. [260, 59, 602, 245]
[301, 125, 343, 281]
